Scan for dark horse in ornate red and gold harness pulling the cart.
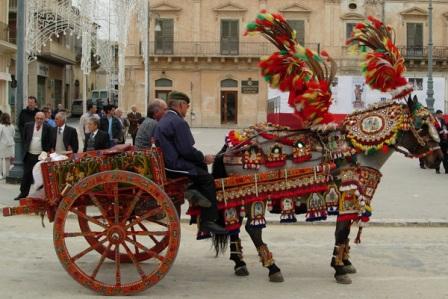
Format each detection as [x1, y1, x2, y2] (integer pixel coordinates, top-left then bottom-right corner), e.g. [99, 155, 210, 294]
[208, 97, 442, 284]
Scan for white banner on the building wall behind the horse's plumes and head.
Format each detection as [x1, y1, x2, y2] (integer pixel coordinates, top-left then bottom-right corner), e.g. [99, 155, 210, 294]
[268, 76, 447, 114]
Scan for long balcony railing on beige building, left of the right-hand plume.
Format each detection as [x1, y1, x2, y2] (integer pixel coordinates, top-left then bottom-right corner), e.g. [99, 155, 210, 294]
[149, 40, 319, 57]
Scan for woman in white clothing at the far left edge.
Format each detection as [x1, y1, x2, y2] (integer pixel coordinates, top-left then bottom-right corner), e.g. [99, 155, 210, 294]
[0, 113, 15, 179]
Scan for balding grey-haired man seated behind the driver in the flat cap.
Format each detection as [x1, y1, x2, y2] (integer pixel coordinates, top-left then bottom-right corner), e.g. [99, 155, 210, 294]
[135, 99, 168, 149]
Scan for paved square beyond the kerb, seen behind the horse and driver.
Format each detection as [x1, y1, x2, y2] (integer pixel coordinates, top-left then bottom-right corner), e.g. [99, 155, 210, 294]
[0, 126, 448, 226]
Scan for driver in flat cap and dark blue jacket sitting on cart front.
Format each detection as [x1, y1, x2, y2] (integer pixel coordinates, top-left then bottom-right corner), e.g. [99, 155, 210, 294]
[155, 92, 227, 234]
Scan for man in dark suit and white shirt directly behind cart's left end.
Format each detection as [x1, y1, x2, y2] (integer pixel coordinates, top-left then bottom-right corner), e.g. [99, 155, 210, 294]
[53, 112, 78, 154]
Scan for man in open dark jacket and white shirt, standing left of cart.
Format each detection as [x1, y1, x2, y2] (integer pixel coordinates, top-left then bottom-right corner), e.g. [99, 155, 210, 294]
[15, 112, 54, 200]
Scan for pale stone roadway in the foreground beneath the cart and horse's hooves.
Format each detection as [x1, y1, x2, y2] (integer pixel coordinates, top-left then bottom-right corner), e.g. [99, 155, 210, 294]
[0, 216, 448, 299]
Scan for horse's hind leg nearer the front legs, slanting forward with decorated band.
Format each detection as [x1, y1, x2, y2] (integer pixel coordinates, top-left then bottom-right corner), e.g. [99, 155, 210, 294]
[245, 223, 284, 282]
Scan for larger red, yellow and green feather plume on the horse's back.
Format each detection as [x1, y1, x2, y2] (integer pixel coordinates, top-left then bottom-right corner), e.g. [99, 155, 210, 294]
[246, 10, 336, 126]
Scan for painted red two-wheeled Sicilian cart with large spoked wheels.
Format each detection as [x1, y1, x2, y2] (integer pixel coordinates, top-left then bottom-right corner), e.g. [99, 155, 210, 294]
[3, 147, 187, 295]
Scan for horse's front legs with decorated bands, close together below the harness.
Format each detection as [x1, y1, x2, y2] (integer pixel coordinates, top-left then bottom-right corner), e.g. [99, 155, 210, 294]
[331, 220, 352, 284]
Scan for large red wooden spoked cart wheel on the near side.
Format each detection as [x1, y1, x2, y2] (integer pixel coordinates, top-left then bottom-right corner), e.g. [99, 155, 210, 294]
[53, 170, 180, 295]
